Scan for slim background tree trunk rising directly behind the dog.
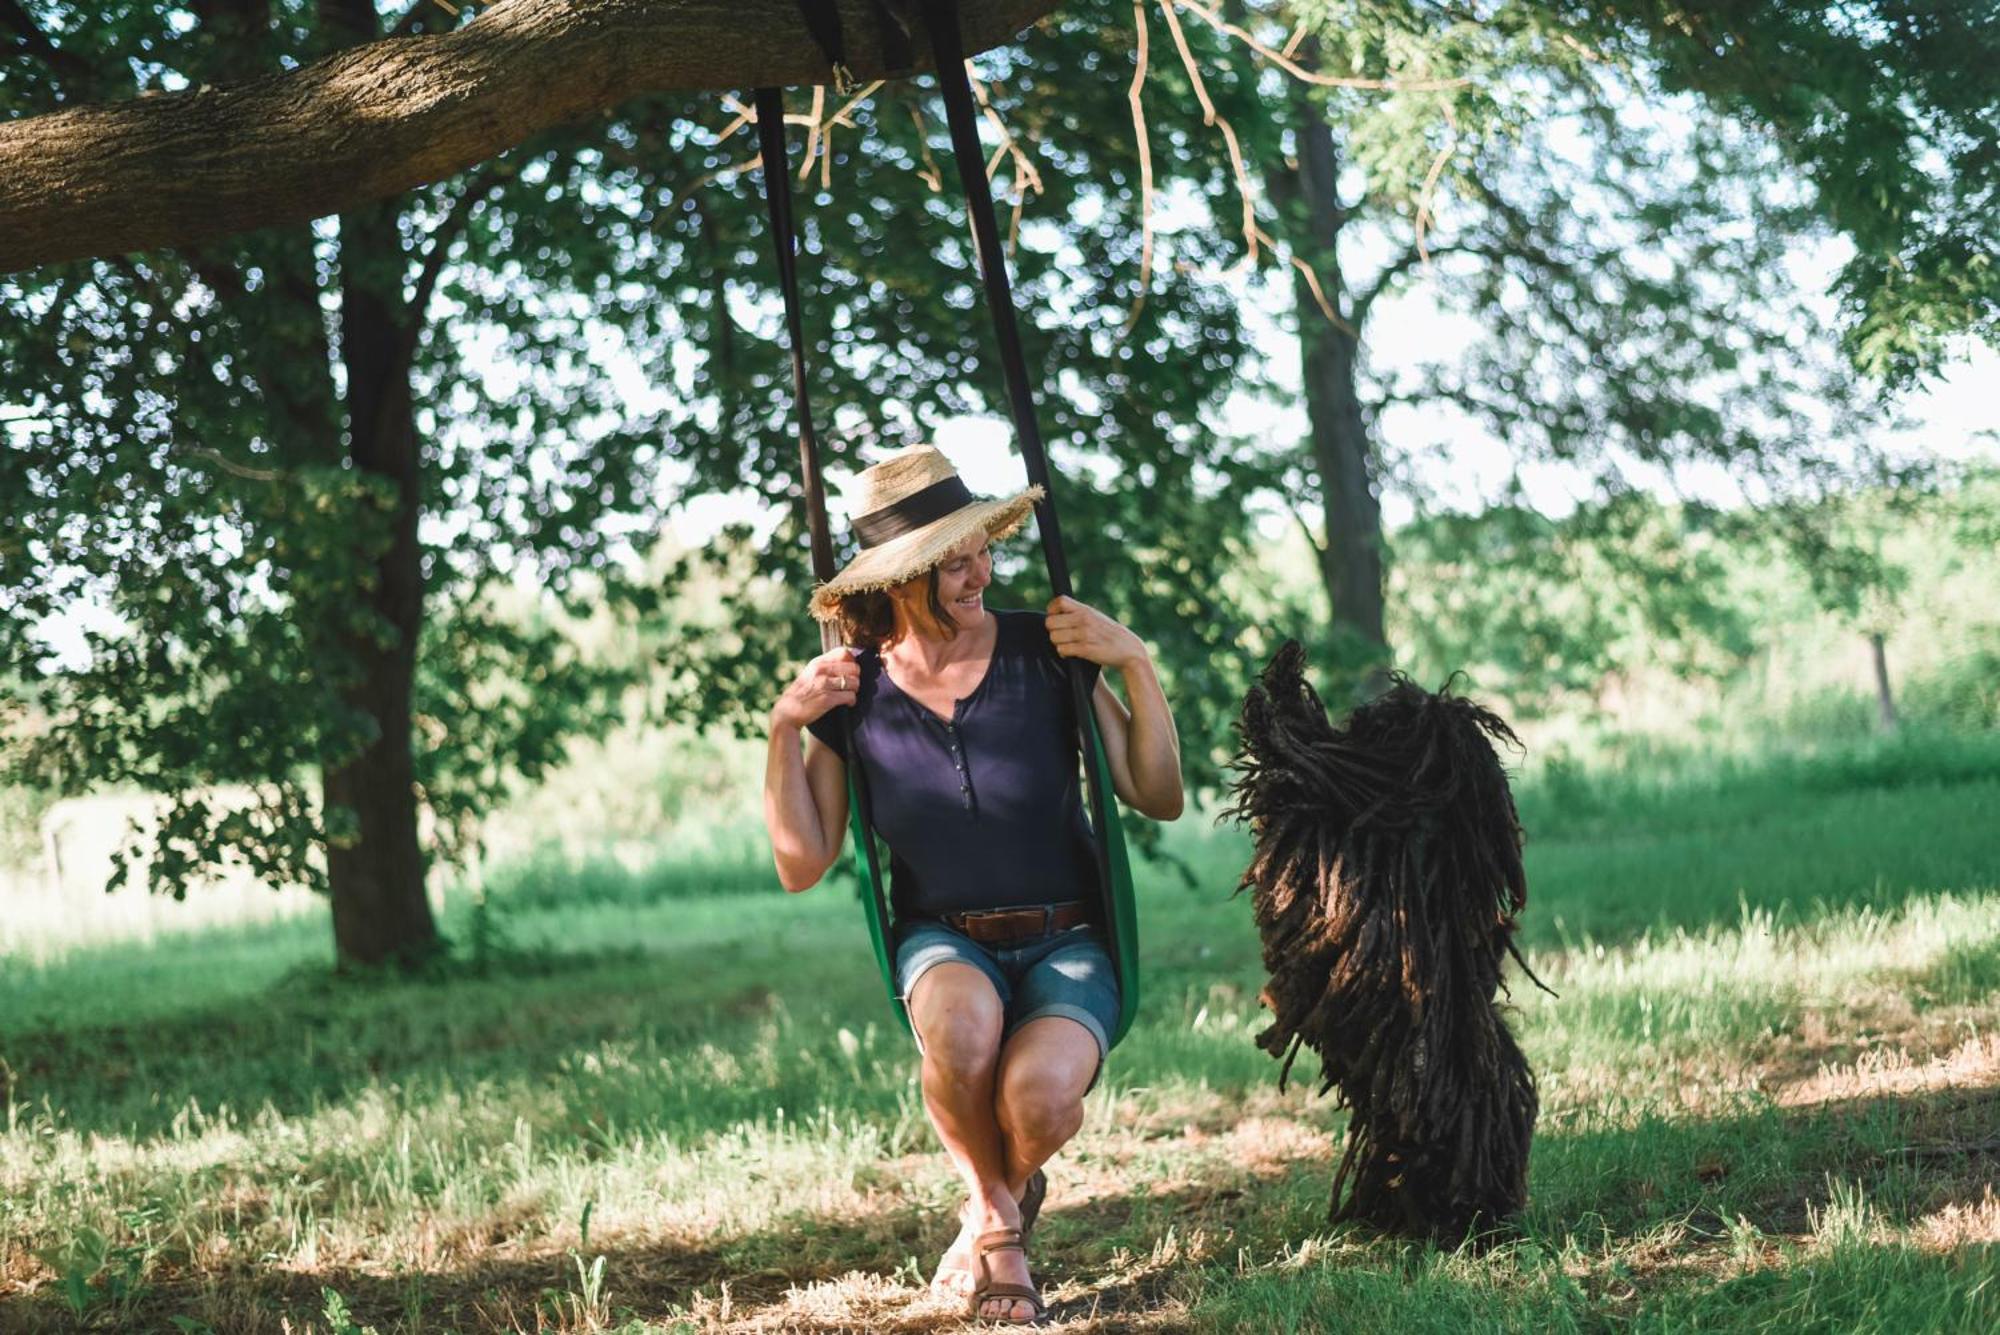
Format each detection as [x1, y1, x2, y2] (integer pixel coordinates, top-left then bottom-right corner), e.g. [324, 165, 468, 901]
[1270, 72, 1388, 675]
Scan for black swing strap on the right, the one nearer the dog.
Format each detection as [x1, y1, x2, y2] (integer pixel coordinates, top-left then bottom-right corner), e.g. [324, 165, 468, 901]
[924, 0, 1112, 895]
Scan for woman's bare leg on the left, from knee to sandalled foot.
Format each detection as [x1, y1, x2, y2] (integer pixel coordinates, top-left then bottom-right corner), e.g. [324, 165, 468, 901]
[910, 963, 1032, 1319]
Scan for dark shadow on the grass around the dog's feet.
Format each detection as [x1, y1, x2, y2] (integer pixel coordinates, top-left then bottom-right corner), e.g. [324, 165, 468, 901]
[1046, 1085, 2000, 1333]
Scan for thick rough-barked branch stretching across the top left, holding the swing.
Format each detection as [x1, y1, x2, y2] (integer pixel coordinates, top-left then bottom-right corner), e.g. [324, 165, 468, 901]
[0, 0, 1054, 274]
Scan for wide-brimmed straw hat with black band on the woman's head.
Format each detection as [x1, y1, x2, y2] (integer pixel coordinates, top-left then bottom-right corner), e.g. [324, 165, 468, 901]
[812, 446, 1042, 622]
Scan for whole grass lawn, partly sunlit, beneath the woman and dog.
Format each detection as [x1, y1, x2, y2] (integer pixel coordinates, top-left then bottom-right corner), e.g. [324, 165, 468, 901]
[0, 743, 2000, 1335]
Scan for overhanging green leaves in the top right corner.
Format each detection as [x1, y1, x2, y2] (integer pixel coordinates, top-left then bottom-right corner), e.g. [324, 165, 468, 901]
[1298, 0, 2000, 386]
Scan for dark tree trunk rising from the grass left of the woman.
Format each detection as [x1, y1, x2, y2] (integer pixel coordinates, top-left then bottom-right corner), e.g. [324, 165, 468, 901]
[320, 0, 438, 965]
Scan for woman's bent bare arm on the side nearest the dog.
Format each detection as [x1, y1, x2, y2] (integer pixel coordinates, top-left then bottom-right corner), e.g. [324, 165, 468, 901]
[1048, 598, 1186, 821]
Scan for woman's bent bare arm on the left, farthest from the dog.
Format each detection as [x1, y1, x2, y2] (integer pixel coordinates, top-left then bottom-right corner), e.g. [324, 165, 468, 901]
[764, 650, 860, 893]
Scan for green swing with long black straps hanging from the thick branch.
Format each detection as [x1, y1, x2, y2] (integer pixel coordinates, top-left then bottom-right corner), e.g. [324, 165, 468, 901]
[756, 0, 1138, 1043]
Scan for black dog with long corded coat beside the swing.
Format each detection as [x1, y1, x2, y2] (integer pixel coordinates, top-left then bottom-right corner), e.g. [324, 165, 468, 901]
[1228, 642, 1538, 1241]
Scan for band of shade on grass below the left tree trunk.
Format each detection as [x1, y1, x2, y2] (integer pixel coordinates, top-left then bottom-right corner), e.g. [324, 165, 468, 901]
[0, 927, 892, 1139]
